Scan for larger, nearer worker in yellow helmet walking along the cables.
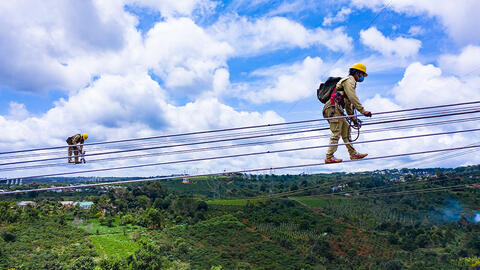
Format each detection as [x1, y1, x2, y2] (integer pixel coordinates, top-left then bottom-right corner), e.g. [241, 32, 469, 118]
[323, 63, 372, 163]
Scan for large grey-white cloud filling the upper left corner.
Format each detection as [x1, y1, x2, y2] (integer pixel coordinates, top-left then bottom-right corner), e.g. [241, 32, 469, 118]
[0, 0, 135, 92]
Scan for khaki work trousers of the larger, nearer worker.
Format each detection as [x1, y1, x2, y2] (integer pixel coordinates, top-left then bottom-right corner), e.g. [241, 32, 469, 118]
[323, 106, 357, 159]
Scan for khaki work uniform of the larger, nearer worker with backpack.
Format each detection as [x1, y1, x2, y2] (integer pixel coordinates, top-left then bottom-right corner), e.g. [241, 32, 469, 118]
[323, 75, 365, 159]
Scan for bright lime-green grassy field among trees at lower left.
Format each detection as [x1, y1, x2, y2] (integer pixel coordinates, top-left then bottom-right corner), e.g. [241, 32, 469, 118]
[90, 233, 139, 258]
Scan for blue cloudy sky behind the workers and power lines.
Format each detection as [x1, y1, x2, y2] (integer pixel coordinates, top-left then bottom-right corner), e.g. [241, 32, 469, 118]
[0, 0, 480, 177]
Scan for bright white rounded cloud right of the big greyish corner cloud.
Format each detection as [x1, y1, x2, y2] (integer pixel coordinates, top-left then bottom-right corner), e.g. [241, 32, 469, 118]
[145, 18, 232, 94]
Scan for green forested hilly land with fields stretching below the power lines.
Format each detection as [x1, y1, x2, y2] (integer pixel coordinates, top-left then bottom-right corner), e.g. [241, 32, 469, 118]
[0, 166, 480, 269]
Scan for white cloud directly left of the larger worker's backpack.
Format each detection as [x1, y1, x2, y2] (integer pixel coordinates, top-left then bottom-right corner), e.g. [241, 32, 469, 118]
[236, 57, 325, 104]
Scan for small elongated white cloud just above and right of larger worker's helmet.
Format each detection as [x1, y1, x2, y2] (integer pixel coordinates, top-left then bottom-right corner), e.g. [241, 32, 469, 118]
[360, 27, 422, 58]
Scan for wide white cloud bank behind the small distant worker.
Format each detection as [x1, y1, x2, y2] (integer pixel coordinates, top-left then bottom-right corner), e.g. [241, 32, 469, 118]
[0, 70, 284, 176]
